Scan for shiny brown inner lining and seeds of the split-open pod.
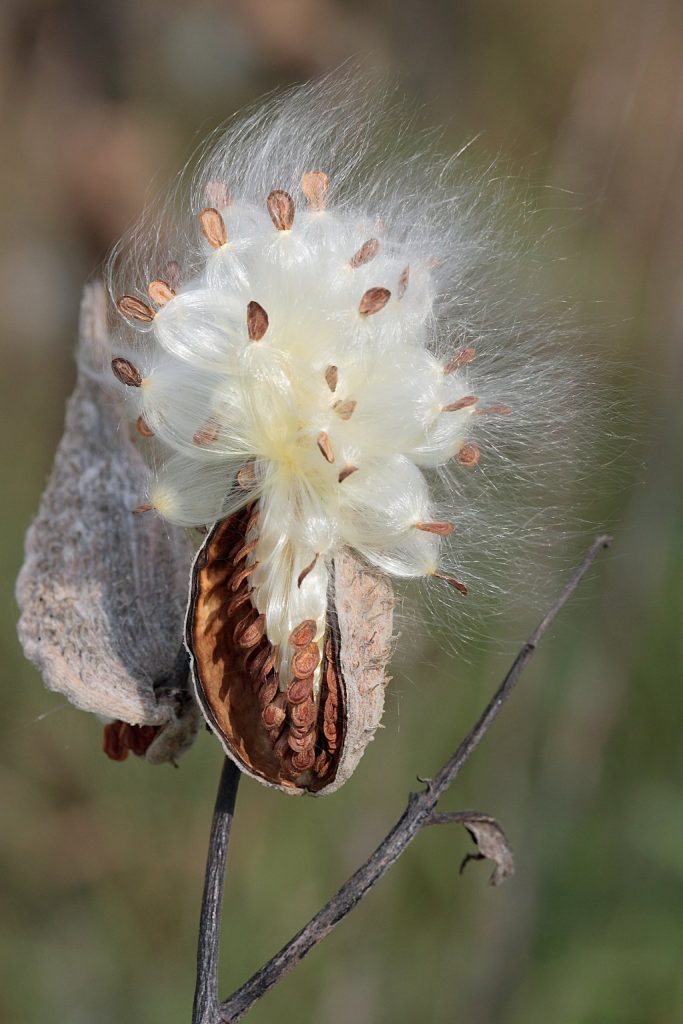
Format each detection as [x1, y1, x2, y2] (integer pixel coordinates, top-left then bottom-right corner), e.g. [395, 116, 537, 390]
[185, 504, 345, 793]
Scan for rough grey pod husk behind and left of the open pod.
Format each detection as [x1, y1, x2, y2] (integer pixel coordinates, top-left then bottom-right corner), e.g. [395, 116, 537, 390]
[16, 285, 197, 760]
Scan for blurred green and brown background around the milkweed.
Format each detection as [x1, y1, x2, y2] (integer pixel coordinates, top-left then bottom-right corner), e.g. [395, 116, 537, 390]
[0, 0, 683, 1024]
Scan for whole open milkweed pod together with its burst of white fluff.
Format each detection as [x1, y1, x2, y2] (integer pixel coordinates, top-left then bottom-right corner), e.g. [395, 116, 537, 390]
[110, 79, 589, 793]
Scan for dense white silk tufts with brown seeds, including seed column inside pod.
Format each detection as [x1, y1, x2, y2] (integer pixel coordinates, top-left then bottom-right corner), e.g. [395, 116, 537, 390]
[112, 171, 511, 776]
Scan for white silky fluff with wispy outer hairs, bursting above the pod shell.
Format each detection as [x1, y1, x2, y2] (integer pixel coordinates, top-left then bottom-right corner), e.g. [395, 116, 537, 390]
[111, 70, 593, 669]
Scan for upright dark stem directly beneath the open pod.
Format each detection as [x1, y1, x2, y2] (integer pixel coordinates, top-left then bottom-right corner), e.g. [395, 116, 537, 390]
[193, 758, 240, 1024]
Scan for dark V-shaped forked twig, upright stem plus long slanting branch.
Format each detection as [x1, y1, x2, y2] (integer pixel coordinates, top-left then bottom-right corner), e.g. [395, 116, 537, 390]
[193, 536, 611, 1024]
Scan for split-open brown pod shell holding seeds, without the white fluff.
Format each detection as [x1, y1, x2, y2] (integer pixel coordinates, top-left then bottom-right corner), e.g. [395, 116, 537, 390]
[185, 503, 393, 796]
